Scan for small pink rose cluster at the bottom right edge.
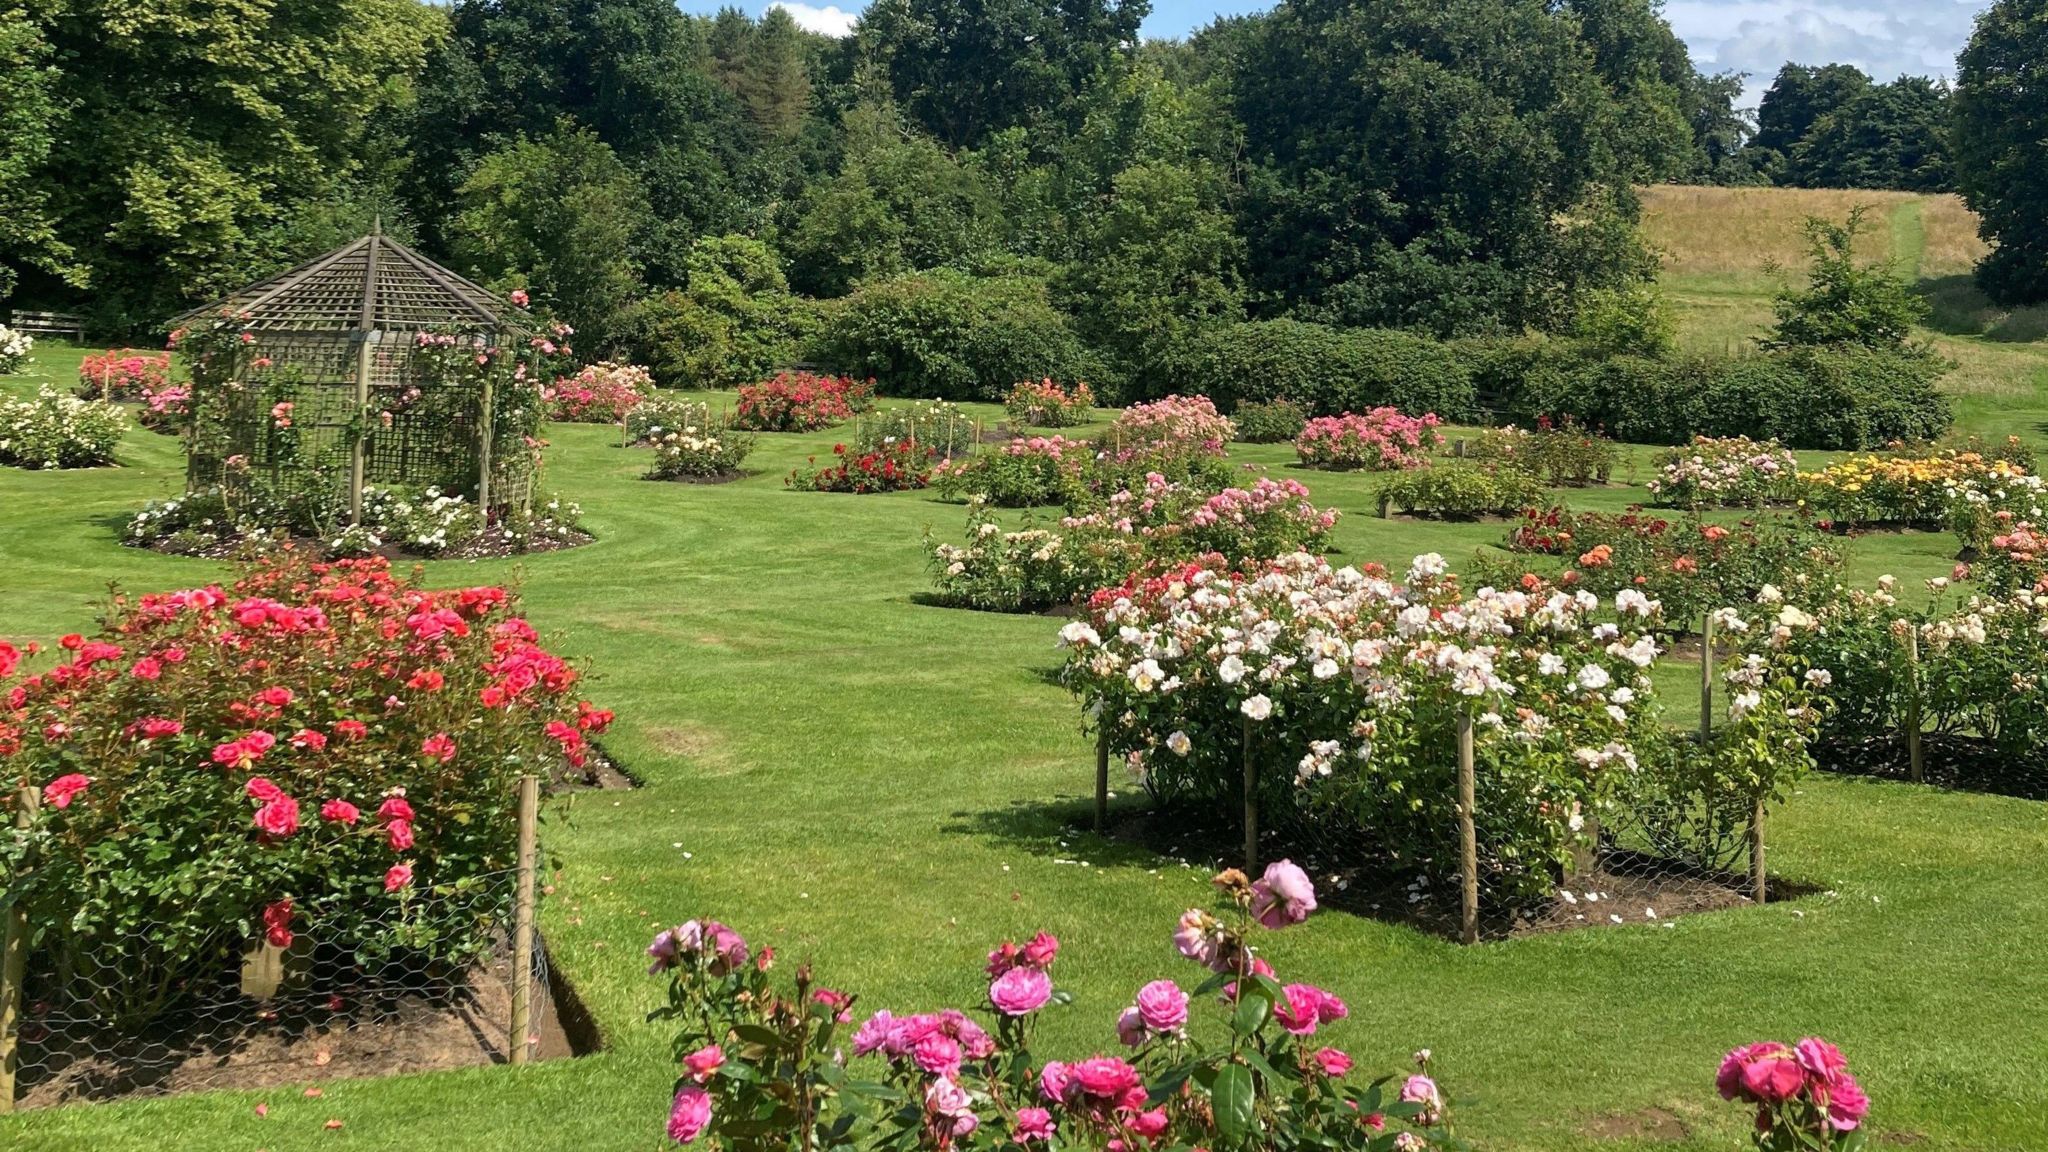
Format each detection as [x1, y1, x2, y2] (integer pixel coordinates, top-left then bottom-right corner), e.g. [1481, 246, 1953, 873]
[1714, 1037, 1870, 1152]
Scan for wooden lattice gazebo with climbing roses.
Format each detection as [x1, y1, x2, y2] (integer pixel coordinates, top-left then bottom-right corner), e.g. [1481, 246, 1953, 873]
[176, 228, 532, 521]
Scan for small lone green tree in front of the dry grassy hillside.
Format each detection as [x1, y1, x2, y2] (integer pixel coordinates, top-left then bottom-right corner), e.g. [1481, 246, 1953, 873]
[1763, 205, 1927, 353]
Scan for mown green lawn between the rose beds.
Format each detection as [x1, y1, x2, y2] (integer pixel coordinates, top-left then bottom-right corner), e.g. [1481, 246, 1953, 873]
[0, 293, 2048, 1152]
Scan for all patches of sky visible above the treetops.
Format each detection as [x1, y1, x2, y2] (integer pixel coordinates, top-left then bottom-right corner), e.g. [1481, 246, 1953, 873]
[712, 0, 1987, 102]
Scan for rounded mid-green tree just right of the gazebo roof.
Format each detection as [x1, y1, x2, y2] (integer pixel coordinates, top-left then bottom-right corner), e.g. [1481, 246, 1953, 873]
[453, 121, 647, 346]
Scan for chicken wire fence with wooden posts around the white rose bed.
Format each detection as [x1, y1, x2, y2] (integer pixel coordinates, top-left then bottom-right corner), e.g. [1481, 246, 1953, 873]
[1094, 664, 1772, 943]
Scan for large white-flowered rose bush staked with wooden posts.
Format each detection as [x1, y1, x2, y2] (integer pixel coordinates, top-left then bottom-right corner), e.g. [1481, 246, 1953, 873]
[1061, 553, 1817, 908]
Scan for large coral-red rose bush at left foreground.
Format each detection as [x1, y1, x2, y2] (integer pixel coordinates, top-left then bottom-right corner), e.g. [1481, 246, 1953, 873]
[0, 551, 610, 1027]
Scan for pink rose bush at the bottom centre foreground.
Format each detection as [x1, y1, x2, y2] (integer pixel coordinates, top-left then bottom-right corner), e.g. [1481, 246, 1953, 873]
[647, 861, 1464, 1152]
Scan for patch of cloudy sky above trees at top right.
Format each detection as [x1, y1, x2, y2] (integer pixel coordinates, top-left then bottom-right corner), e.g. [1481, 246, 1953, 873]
[1665, 0, 1989, 105]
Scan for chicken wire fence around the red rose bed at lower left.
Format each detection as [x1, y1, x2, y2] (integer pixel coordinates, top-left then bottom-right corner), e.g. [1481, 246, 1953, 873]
[0, 778, 565, 1111]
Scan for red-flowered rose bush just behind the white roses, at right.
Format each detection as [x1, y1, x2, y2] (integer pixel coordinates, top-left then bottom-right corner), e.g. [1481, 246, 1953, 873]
[1505, 508, 1841, 627]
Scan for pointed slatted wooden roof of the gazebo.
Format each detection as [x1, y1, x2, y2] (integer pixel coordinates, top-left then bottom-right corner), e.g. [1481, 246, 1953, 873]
[176, 228, 520, 336]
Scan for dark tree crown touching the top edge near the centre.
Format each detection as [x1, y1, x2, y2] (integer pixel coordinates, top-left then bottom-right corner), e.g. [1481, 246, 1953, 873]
[860, 0, 1151, 148]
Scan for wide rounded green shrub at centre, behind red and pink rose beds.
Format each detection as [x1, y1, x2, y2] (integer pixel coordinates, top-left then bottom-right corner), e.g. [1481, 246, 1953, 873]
[817, 269, 1102, 400]
